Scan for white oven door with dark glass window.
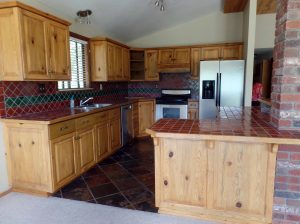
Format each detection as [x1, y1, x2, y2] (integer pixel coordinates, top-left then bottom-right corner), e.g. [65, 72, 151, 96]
[156, 104, 188, 120]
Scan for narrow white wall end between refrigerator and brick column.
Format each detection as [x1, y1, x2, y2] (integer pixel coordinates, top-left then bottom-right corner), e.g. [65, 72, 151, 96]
[243, 0, 257, 106]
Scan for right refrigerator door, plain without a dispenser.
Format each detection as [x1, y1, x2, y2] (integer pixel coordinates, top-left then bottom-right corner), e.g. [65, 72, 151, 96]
[219, 60, 245, 107]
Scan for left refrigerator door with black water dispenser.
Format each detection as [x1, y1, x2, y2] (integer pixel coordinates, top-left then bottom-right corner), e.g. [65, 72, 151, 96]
[199, 61, 220, 119]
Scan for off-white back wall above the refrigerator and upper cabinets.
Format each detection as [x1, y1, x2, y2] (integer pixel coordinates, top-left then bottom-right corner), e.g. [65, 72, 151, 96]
[127, 12, 243, 47]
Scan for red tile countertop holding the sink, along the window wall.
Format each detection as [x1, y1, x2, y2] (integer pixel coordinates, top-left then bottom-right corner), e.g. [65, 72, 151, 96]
[0, 98, 154, 124]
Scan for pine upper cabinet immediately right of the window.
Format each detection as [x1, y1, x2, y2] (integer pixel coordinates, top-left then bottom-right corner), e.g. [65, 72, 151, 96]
[90, 38, 129, 82]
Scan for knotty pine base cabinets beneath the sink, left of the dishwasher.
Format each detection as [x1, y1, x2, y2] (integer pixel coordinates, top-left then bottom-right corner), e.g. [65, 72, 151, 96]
[4, 107, 122, 195]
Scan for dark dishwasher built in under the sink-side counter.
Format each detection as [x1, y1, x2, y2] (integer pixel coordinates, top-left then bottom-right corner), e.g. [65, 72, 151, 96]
[121, 104, 134, 146]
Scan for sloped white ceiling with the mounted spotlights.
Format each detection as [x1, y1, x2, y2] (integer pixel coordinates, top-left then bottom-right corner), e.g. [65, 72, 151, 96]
[38, 0, 222, 42]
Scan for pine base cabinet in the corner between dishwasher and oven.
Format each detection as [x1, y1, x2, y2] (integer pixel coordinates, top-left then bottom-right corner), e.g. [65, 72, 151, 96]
[133, 100, 155, 137]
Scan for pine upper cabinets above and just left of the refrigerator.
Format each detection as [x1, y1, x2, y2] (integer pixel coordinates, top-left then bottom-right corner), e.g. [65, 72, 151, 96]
[191, 43, 243, 79]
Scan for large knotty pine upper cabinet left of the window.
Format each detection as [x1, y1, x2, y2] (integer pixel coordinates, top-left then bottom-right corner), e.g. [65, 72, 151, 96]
[0, 2, 70, 81]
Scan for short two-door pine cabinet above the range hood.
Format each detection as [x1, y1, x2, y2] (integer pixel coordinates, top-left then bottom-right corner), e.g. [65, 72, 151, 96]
[158, 48, 191, 72]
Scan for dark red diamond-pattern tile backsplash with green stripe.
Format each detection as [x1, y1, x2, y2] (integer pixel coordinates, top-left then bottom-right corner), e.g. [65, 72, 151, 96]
[0, 73, 199, 117]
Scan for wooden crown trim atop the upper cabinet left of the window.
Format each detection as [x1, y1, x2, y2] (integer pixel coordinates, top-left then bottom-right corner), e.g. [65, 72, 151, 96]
[0, 1, 71, 26]
